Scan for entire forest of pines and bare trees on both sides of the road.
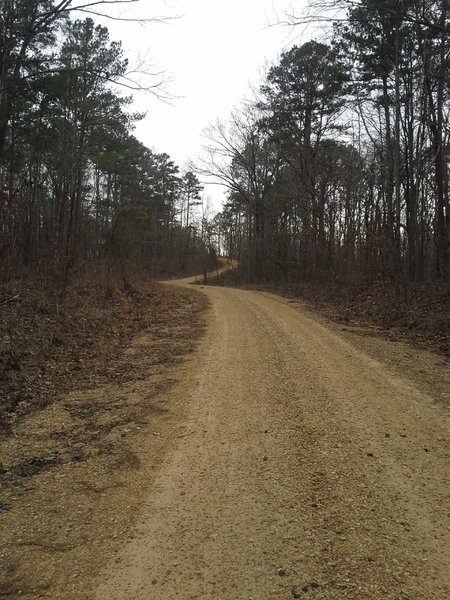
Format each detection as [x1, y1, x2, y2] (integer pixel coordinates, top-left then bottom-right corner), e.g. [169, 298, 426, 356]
[0, 0, 450, 290]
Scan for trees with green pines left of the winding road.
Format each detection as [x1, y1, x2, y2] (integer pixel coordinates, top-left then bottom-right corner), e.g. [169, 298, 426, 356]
[0, 0, 207, 289]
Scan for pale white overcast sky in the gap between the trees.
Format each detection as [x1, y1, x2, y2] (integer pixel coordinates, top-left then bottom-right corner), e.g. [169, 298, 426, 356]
[96, 0, 312, 210]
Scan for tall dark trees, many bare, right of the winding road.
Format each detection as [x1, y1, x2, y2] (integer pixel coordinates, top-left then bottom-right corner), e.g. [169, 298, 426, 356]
[209, 0, 450, 283]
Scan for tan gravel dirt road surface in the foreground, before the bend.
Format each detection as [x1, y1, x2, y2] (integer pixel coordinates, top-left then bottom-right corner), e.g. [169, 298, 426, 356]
[94, 287, 450, 600]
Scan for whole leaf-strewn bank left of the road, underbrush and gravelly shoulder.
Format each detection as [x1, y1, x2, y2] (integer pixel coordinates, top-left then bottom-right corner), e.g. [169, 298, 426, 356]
[0, 274, 207, 599]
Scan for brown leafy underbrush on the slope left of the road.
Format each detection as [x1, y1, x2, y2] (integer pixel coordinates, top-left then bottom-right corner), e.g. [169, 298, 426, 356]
[0, 271, 207, 435]
